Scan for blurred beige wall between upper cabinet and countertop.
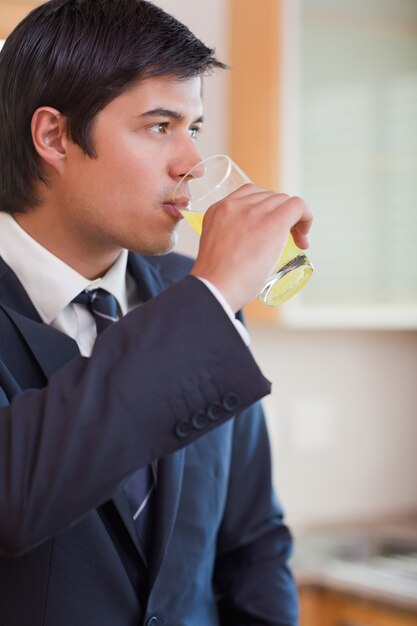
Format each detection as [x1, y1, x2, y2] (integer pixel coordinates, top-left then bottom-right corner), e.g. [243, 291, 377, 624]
[251, 328, 417, 525]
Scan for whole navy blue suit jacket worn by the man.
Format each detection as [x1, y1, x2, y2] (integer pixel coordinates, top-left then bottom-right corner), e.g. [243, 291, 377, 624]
[0, 254, 297, 626]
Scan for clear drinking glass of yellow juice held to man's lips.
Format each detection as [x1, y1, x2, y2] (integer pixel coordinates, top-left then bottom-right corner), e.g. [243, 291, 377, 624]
[173, 154, 313, 306]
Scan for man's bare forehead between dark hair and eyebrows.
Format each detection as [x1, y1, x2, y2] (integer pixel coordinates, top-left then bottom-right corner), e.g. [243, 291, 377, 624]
[106, 75, 203, 119]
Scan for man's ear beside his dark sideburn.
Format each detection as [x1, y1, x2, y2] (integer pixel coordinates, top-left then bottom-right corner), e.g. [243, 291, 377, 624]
[31, 106, 67, 170]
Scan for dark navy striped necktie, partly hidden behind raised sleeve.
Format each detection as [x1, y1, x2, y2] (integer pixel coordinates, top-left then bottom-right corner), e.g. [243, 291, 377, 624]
[73, 289, 155, 560]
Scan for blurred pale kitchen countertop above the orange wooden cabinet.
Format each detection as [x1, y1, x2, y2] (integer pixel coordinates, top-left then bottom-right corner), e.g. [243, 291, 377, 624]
[292, 515, 417, 616]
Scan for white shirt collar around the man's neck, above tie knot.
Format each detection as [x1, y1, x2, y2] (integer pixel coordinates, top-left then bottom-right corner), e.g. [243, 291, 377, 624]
[0, 212, 128, 324]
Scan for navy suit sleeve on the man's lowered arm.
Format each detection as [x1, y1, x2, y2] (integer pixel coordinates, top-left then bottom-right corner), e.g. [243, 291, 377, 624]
[214, 403, 298, 626]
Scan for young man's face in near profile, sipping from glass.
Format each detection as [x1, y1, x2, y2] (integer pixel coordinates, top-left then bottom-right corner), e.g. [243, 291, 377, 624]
[55, 76, 203, 254]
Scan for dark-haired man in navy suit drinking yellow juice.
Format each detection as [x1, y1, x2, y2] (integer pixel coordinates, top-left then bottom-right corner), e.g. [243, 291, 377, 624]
[0, 0, 311, 626]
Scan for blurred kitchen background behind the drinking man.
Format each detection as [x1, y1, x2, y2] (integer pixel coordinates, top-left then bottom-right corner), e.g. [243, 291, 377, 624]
[0, 0, 417, 626]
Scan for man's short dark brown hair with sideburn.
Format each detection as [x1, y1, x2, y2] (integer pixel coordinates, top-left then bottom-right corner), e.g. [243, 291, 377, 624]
[0, 0, 225, 212]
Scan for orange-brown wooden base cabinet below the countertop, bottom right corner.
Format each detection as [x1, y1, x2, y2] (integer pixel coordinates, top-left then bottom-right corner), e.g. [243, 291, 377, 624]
[300, 586, 417, 626]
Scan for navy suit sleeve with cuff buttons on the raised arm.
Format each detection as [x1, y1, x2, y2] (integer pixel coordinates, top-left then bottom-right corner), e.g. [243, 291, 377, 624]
[0, 276, 270, 554]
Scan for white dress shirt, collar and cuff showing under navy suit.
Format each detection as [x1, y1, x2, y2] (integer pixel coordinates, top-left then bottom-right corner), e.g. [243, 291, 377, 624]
[0, 212, 249, 356]
